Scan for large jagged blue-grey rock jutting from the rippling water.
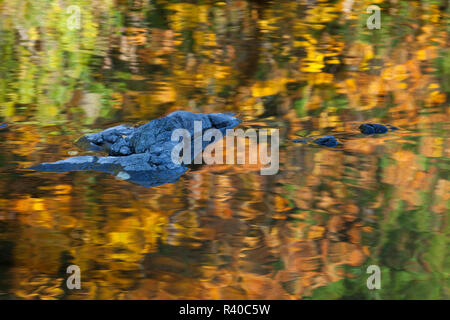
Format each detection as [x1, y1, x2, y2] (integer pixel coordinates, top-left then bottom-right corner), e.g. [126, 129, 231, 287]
[28, 111, 241, 187]
